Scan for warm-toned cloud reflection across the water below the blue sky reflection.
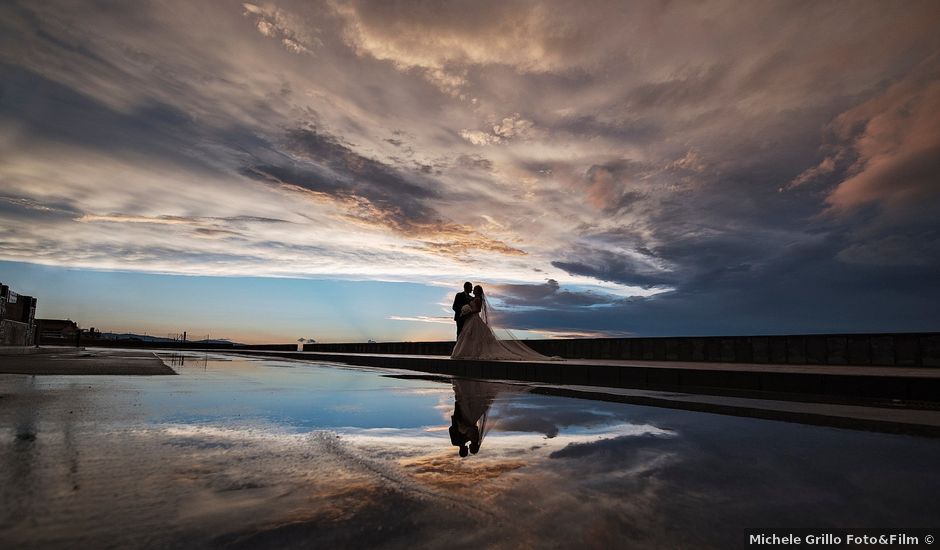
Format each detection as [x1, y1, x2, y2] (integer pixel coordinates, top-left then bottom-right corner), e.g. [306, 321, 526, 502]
[6, 410, 684, 547]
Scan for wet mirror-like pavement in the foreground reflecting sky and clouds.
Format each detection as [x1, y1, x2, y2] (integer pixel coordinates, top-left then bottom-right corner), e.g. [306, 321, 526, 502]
[0, 353, 940, 548]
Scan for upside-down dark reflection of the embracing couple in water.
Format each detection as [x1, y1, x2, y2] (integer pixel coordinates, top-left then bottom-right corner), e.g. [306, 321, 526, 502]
[448, 379, 506, 457]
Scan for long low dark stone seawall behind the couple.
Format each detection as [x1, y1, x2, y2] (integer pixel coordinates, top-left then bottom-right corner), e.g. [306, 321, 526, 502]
[304, 332, 940, 367]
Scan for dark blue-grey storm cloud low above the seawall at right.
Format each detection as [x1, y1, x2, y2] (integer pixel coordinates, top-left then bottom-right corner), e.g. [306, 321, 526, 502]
[520, 235, 940, 335]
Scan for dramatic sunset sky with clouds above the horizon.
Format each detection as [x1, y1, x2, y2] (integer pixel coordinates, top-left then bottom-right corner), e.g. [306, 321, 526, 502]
[0, 0, 940, 342]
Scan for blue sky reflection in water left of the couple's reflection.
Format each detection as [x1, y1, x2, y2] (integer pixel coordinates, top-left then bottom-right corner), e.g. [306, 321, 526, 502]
[146, 357, 450, 429]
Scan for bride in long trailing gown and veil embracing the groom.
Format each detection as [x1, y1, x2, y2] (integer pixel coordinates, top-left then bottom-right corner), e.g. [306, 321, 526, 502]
[450, 285, 561, 361]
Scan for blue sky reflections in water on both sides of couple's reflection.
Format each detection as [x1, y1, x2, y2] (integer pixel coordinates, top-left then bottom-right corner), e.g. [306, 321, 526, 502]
[147, 355, 664, 441]
